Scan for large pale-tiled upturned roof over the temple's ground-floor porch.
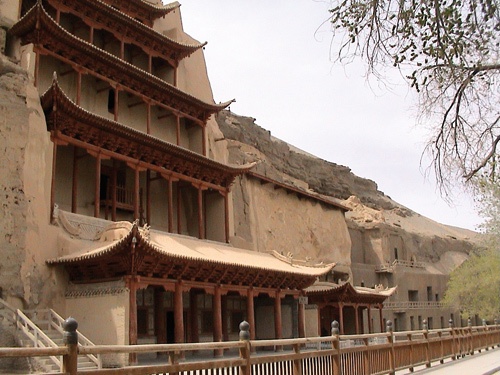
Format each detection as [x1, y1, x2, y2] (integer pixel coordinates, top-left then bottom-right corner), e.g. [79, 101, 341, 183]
[47, 211, 334, 290]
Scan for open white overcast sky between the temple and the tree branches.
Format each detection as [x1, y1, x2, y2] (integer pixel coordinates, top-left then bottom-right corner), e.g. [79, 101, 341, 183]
[180, 0, 481, 229]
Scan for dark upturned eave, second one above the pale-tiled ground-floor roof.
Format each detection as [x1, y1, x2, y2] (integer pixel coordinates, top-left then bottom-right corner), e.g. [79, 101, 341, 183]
[9, 3, 232, 125]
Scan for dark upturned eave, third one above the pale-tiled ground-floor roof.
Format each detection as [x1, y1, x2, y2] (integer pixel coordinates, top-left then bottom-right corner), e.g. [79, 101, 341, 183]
[48, 0, 206, 66]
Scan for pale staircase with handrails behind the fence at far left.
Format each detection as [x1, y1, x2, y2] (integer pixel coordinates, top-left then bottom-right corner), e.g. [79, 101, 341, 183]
[0, 299, 102, 373]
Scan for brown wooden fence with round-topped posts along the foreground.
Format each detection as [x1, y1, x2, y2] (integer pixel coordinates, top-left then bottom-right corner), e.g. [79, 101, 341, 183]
[0, 319, 500, 375]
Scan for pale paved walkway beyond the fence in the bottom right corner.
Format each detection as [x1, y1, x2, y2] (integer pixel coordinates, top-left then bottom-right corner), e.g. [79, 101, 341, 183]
[396, 347, 500, 375]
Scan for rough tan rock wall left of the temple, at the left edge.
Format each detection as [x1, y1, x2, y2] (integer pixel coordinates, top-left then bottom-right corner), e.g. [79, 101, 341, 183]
[0, 56, 62, 308]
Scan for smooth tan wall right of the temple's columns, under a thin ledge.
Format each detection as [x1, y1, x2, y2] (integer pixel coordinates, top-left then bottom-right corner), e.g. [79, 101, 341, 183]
[231, 177, 351, 264]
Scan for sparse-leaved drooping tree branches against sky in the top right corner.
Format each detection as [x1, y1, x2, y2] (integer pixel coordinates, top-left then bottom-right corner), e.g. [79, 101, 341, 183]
[331, 0, 500, 192]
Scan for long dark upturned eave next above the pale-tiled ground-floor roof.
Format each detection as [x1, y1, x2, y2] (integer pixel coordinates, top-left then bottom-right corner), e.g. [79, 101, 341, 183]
[41, 79, 253, 190]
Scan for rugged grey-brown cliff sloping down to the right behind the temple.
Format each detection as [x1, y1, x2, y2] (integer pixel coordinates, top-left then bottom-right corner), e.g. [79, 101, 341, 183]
[217, 111, 476, 273]
